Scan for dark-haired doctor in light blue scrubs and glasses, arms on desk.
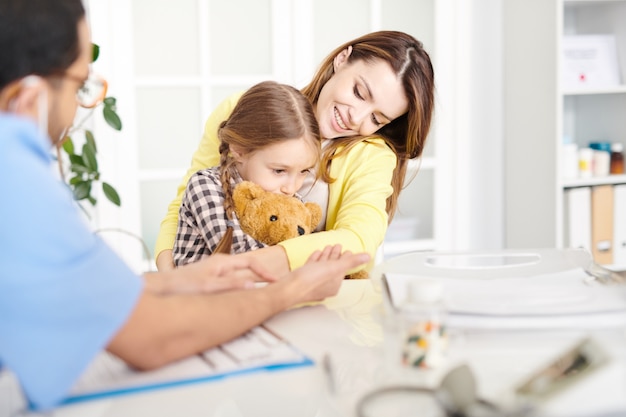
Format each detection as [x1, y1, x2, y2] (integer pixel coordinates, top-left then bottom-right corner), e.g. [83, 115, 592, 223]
[0, 0, 369, 409]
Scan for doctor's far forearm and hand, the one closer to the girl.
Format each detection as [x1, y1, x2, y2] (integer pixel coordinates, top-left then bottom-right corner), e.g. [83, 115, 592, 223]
[145, 254, 277, 295]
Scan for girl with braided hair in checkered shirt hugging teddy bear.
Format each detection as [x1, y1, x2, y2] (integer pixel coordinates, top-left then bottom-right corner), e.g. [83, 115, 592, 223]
[174, 81, 321, 266]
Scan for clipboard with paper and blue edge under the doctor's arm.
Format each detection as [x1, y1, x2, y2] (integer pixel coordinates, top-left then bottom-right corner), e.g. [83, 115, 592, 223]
[64, 326, 313, 404]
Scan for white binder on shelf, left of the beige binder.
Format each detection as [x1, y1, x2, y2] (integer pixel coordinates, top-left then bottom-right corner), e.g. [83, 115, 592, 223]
[564, 187, 591, 252]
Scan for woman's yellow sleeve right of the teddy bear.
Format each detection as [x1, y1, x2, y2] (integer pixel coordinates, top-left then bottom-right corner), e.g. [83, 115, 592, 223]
[279, 139, 397, 272]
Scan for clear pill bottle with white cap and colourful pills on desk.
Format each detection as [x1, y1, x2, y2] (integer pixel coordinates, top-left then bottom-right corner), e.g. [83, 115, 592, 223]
[400, 279, 448, 369]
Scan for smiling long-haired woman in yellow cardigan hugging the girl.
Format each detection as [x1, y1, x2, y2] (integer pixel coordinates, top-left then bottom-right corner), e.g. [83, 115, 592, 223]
[155, 31, 435, 273]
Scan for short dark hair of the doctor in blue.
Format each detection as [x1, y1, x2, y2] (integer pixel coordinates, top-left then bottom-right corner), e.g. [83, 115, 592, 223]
[0, 0, 85, 90]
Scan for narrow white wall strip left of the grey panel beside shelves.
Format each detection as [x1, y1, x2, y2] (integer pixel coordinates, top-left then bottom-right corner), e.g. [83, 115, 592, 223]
[455, 0, 506, 250]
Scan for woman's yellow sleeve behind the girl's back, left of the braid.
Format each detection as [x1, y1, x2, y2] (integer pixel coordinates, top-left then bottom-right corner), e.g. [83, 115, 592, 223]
[154, 92, 243, 259]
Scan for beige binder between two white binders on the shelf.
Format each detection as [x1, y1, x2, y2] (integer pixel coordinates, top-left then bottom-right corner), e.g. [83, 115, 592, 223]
[591, 185, 613, 264]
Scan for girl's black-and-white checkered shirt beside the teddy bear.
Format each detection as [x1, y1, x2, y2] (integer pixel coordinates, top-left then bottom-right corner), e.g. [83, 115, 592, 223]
[174, 167, 267, 266]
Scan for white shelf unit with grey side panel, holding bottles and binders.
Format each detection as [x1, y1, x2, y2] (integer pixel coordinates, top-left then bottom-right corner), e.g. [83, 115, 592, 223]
[503, 0, 626, 266]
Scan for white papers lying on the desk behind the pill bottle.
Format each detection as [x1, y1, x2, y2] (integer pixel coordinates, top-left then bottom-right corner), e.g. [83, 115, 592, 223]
[383, 269, 626, 327]
